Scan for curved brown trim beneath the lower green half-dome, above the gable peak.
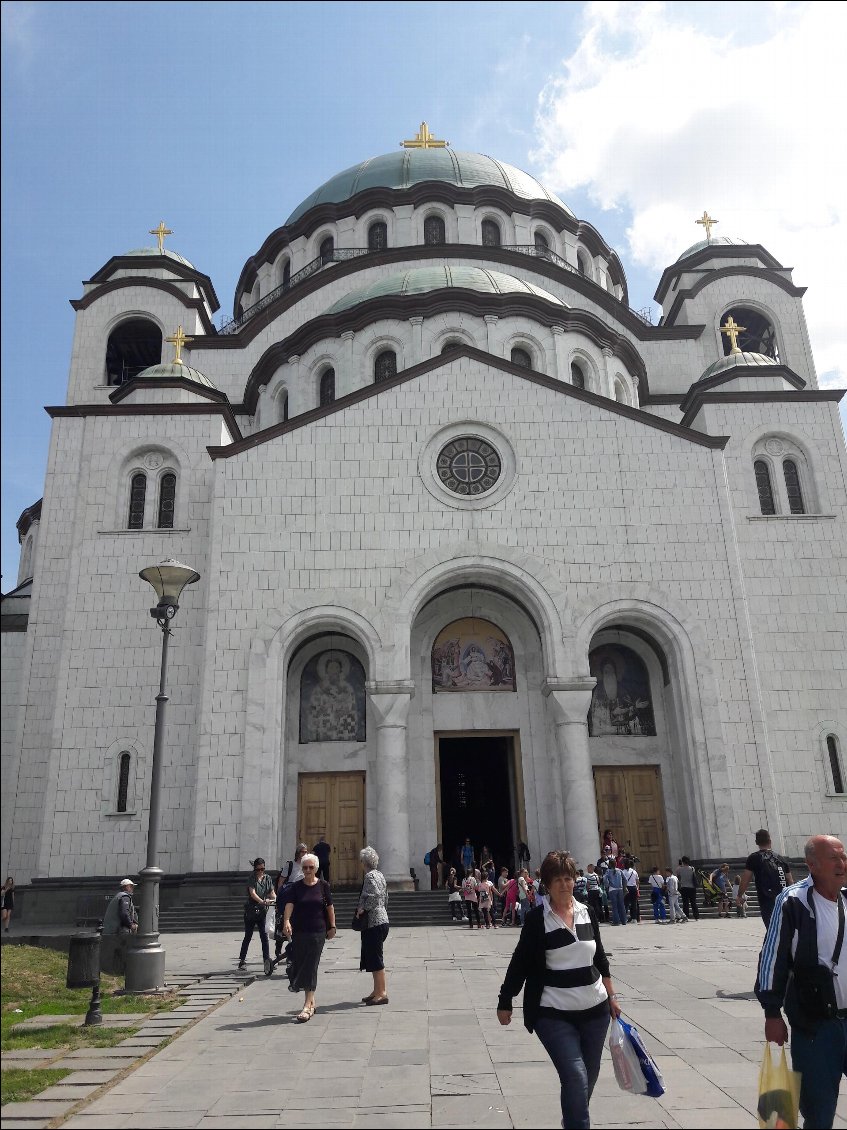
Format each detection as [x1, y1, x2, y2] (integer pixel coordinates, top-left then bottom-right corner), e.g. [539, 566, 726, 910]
[244, 287, 649, 412]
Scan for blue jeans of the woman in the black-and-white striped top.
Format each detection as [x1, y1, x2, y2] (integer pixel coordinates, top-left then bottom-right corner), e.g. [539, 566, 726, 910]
[535, 1011, 610, 1130]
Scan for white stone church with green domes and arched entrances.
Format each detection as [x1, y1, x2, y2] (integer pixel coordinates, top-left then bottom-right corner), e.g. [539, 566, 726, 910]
[2, 129, 847, 899]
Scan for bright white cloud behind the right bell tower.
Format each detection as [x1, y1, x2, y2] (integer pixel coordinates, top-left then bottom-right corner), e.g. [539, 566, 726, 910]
[533, 2, 847, 384]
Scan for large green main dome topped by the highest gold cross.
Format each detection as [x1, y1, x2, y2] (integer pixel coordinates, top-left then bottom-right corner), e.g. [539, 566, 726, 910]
[286, 149, 574, 224]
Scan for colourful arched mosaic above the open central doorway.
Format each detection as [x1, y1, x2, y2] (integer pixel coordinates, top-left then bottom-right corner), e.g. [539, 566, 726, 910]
[433, 617, 516, 692]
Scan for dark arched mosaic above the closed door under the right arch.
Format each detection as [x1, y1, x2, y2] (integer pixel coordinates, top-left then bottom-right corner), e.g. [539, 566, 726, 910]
[588, 644, 656, 737]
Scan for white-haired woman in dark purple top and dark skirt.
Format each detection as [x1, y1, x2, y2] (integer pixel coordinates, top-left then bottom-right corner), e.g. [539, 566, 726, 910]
[282, 852, 335, 1024]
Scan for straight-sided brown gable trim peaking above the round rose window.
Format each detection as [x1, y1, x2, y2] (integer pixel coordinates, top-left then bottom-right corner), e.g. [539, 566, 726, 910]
[207, 346, 728, 459]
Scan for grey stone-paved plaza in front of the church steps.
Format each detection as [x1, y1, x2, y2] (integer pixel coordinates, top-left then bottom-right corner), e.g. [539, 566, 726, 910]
[4, 919, 847, 1130]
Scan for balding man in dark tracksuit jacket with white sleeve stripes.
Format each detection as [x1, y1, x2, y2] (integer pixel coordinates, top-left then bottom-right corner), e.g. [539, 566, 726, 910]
[756, 836, 847, 1130]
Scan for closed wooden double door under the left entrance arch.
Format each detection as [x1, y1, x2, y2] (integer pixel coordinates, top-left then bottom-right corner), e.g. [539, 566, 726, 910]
[297, 773, 365, 887]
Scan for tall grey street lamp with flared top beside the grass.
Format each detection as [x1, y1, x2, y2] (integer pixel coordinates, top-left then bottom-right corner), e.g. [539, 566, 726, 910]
[126, 560, 200, 992]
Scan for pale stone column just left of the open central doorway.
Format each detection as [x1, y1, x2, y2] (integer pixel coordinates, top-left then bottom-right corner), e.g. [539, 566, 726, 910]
[367, 680, 414, 890]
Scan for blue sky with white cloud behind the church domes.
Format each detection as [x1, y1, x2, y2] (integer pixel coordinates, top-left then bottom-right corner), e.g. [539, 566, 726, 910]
[2, 0, 847, 590]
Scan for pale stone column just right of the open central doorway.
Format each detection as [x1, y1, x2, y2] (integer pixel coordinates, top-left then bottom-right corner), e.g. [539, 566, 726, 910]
[543, 676, 600, 867]
